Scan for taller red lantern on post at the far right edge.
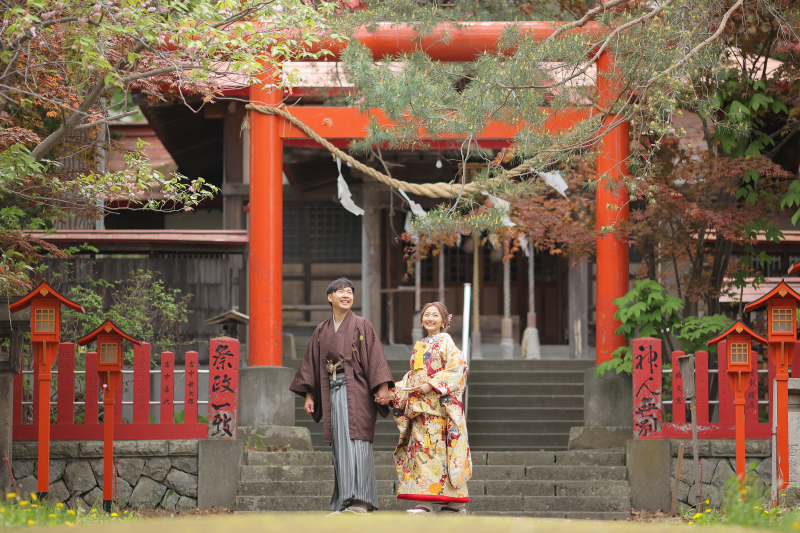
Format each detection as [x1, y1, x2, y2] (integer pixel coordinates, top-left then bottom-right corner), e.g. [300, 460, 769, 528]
[744, 280, 800, 490]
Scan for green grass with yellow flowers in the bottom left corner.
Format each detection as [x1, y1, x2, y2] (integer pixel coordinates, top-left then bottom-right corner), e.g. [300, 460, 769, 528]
[0, 492, 138, 529]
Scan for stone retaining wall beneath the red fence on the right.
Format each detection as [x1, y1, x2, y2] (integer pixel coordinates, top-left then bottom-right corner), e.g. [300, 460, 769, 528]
[670, 439, 772, 510]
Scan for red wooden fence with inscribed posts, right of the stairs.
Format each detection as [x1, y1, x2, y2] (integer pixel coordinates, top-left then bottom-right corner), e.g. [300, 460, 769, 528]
[633, 338, 800, 439]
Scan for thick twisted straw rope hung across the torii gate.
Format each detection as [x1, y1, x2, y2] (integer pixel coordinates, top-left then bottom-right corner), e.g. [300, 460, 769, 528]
[242, 104, 531, 198]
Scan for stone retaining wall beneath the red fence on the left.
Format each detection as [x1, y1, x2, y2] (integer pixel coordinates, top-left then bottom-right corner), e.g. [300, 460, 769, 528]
[12, 439, 199, 509]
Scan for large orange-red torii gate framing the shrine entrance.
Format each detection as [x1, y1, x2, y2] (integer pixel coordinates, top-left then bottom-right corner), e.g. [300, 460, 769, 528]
[248, 22, 629, 366]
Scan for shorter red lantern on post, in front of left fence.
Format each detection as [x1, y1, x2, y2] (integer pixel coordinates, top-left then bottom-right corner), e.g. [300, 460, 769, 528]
[78, 319, 142, 512]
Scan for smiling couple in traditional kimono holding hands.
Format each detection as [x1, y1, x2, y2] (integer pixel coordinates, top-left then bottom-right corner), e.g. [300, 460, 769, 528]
[290, 278, 472, 514]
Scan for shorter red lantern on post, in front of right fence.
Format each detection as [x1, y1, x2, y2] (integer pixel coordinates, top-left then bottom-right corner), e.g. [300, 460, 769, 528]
[708, 320, 767, 481]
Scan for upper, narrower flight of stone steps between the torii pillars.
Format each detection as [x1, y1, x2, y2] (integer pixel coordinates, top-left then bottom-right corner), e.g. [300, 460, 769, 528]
[284, 359, 595, 452]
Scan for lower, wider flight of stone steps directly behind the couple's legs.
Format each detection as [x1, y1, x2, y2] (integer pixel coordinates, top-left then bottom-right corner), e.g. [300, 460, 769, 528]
[236, 451, 630, 520]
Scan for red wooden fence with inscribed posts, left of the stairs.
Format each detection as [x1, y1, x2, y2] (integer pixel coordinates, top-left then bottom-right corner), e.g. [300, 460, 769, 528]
[13, 338, 239, 441]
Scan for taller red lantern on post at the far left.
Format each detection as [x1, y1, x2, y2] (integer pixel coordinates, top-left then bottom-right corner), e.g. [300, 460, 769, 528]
[8, 281, 86, 498]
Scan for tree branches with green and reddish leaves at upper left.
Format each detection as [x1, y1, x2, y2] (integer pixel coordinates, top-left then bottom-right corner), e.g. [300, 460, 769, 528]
[0, 0, 342, 294]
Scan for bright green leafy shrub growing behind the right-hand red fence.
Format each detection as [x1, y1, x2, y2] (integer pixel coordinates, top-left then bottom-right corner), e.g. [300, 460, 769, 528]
[595, 279, 730, 376]
